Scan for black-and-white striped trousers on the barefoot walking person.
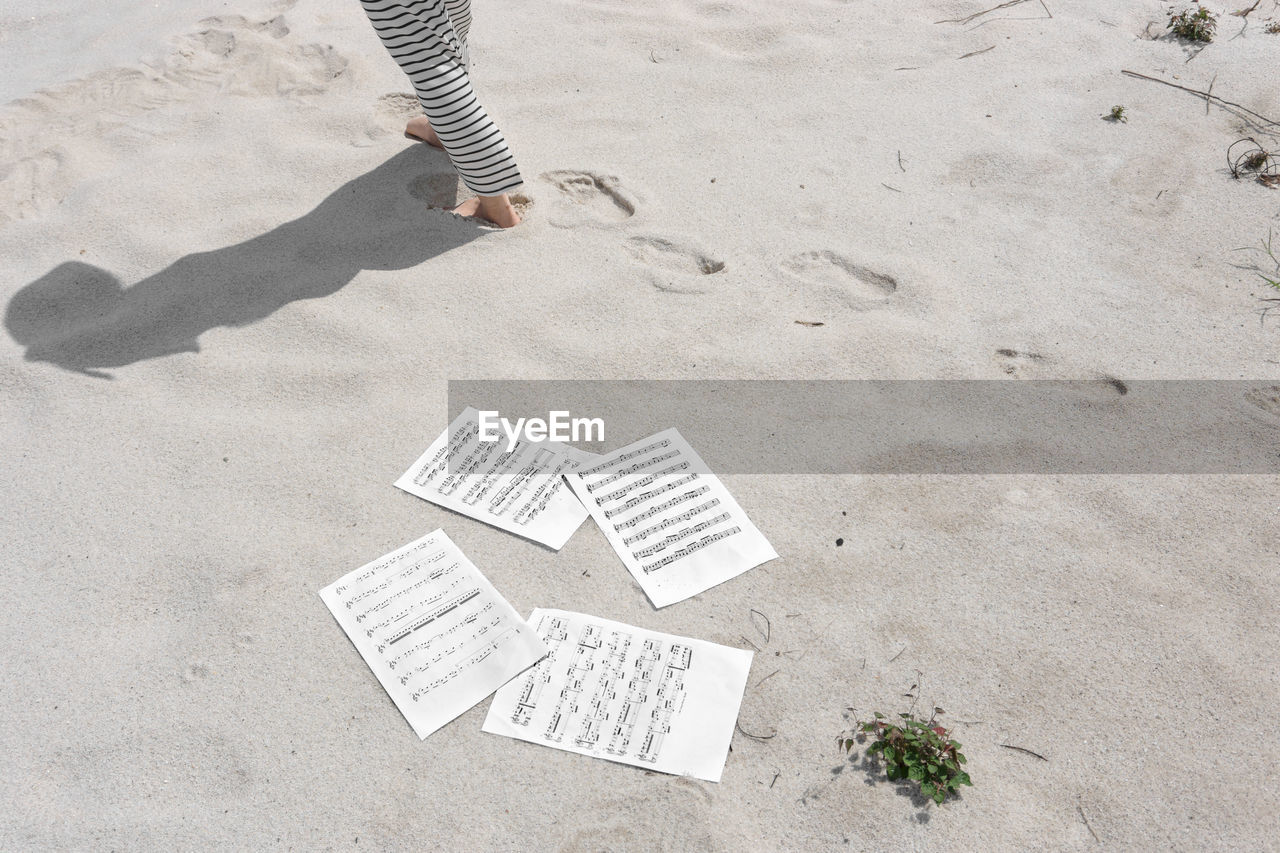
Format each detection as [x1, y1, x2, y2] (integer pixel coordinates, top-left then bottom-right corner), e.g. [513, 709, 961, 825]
[360, 0, 521, 196]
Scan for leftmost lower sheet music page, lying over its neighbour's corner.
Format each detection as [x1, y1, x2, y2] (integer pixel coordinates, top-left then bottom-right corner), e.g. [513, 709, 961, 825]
[320, 530, 547, 738]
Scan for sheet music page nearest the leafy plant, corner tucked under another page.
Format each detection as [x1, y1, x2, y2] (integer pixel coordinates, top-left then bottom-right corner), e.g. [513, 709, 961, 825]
[484, 608, 751, 783]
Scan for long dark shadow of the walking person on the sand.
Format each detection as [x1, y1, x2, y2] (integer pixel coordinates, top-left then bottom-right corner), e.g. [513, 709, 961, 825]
[5, 146, 486, 379]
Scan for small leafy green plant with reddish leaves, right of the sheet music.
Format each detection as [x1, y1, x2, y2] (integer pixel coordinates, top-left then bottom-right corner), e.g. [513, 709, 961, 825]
[840, 708, 973, 806]
